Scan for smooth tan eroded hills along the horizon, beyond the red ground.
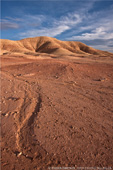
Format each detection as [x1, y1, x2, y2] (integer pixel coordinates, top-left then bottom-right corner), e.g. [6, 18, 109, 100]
[1, 36, 112, 56]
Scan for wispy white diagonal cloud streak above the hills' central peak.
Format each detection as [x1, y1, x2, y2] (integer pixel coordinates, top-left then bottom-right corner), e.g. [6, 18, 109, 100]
[19, 13, 82, 38]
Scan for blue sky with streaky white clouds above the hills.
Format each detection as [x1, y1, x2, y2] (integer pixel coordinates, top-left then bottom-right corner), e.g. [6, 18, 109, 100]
[0, 0, 113, 52]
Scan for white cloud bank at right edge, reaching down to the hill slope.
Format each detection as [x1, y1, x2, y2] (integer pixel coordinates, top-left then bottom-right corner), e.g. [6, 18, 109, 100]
[65, 4, 113, 52]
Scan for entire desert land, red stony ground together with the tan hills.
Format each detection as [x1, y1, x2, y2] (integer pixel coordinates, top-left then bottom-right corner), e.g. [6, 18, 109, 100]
[1, 37, 113, 170]
